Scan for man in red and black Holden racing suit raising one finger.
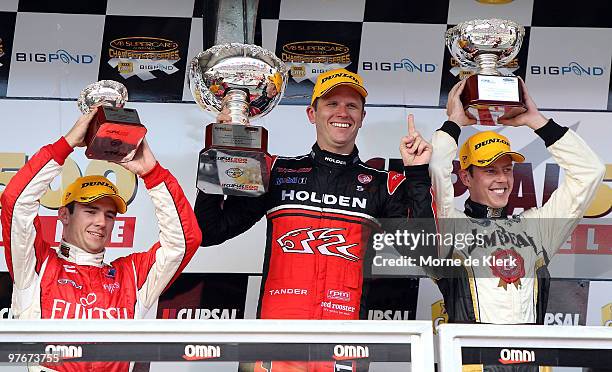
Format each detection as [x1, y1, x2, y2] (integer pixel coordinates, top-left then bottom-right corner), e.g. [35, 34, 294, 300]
[195, 69, 433, 372]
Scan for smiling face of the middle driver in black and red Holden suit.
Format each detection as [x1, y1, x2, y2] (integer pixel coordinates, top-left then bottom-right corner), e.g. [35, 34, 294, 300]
[306, 85, 365, 154]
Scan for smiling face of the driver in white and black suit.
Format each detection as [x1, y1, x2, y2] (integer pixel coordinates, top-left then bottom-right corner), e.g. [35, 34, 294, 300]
[459, 155, 514, 208]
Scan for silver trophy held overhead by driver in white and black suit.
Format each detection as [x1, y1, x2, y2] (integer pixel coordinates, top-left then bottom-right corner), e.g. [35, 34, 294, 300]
[446, 19, 527, 125]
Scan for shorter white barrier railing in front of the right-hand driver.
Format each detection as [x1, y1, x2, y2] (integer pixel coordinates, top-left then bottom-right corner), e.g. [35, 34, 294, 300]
[437, 324, 612, 372]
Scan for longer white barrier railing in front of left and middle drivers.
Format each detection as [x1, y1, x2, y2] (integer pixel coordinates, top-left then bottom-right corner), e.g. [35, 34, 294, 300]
[0, 319, 434, 372]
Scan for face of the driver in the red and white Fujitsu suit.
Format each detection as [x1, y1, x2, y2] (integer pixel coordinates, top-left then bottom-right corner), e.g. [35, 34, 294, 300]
[59, 197, 117, 253]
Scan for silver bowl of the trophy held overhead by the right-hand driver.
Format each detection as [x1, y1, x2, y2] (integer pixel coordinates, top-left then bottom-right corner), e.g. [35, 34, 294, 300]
[446, 19, 525, 75]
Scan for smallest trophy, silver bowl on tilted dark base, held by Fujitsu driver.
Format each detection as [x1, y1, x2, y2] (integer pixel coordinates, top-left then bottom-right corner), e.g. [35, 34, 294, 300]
[77, 80, 147, 163]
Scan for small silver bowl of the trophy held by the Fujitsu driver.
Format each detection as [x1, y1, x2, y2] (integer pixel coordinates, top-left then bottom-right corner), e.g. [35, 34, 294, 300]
[77, 80, 128, 114]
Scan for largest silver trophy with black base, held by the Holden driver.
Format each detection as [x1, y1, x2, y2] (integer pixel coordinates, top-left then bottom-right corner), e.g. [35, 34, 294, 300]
[189, 43, 287, 196]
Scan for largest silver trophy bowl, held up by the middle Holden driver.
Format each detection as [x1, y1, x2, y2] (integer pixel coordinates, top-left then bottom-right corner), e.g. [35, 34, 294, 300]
[189, 43, 288, 124]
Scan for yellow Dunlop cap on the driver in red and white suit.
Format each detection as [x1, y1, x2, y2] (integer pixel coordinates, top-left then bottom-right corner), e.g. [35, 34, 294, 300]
[62, 176, 127, 213]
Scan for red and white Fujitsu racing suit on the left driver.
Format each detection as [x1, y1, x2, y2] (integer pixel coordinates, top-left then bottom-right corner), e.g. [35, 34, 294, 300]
[1, 137, 202, 372]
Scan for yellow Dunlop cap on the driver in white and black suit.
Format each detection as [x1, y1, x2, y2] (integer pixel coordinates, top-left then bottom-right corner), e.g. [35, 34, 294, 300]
[459, 130, 525, 169]
